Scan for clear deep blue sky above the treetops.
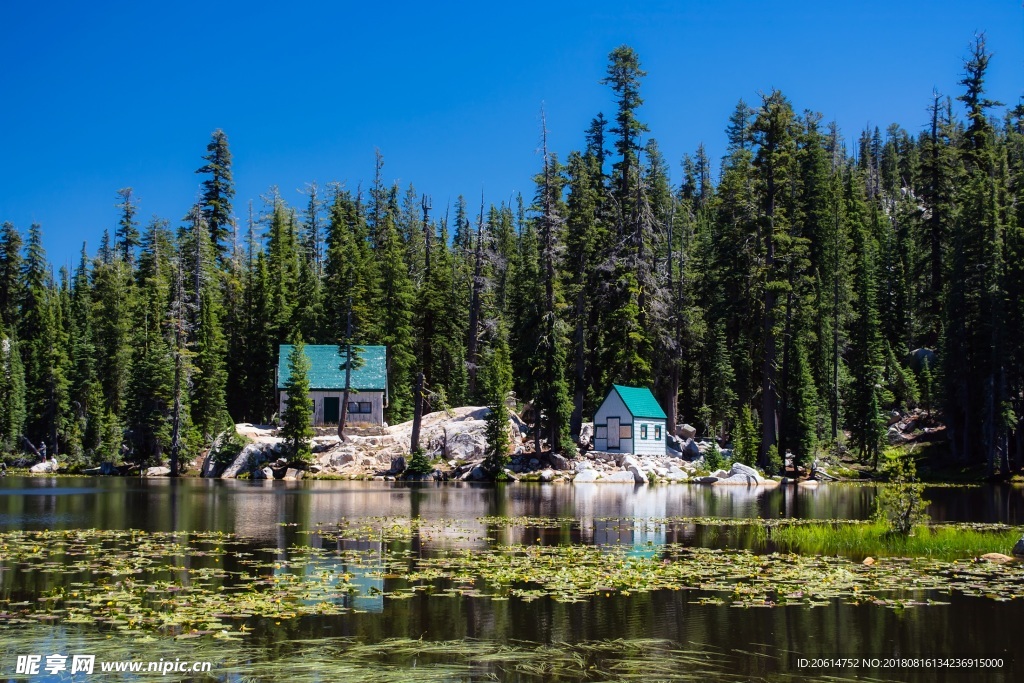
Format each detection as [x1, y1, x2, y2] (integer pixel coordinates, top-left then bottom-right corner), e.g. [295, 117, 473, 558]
[0, 0, 1024, 265]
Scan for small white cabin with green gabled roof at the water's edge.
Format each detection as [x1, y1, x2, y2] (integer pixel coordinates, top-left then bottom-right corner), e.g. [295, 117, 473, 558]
[594, 384, 667, 456]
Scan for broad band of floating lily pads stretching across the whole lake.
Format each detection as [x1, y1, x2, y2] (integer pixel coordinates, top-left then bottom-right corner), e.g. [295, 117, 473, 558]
[0, 517, 1024, 637]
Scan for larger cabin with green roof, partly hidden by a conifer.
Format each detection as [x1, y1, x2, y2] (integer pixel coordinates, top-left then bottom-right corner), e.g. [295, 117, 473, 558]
[278, 344, 387, 426]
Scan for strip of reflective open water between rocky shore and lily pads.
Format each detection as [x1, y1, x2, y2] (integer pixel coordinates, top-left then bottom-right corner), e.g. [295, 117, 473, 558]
[0, 477, 1024, 544]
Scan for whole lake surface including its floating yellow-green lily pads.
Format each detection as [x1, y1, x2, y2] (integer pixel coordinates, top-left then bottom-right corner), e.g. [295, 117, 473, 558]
[0, 476, 1024, 682]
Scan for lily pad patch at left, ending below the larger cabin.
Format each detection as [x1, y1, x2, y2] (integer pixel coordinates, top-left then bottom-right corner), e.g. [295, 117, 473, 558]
[0, 529, 355, 634]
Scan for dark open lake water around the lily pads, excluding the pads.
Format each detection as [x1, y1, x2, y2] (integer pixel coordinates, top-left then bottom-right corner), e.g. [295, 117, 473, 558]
[0, 477, 1024, 682]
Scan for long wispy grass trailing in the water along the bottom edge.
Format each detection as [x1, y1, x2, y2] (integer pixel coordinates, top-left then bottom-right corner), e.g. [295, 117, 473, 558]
[0, 627, 782, 683]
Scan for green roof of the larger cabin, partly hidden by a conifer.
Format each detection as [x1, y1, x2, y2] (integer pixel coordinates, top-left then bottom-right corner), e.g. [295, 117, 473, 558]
[278, 344, 387, 391]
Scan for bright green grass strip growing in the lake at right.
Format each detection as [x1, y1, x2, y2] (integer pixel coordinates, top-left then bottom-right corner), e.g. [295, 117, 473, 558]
[770, 523, 1021, 560]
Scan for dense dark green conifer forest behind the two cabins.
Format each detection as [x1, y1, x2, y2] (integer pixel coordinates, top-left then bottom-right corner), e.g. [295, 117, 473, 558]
[0, 37, 1024, 473]
